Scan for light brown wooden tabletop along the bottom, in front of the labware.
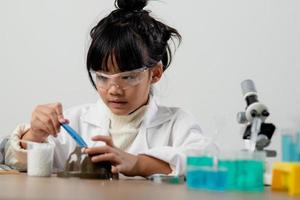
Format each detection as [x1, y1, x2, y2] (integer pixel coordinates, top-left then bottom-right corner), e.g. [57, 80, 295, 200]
[0, 173, 300, 200]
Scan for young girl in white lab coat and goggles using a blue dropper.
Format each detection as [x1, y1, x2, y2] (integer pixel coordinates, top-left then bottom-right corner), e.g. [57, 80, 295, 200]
[5, 0, 211, 177]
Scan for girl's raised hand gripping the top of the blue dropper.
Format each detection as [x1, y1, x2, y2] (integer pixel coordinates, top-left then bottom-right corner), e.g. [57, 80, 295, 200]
[22, 103, 69, 146]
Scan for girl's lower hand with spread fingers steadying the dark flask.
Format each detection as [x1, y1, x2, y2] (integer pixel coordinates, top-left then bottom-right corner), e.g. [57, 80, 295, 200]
[84, 135, 138, 176]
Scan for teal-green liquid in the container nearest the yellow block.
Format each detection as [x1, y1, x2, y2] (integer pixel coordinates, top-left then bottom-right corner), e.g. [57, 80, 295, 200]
[236, 160, 264, 192]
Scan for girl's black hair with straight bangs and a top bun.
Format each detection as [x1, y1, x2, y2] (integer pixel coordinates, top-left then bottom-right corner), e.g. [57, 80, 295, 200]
[87, 0, 181, 87]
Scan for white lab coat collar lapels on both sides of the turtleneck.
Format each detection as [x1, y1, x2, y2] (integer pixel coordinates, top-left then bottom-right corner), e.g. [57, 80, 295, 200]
[81, 95, 172, 129]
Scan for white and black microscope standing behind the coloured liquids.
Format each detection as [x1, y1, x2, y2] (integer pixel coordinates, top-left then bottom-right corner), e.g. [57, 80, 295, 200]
[237, 79, 276, 157]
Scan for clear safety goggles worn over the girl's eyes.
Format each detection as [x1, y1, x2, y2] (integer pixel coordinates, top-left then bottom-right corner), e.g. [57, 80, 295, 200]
[91, 67, 148, 90]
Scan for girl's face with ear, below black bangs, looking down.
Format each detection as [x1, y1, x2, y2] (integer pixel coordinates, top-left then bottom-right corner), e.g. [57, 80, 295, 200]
[95, 59, 162, 115]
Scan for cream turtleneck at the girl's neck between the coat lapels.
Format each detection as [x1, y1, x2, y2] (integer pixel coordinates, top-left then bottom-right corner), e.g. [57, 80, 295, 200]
[109, 105, 147, 150]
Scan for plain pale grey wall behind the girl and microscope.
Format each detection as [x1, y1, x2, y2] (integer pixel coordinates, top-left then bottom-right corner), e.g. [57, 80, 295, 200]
[0, 0, 300, 159]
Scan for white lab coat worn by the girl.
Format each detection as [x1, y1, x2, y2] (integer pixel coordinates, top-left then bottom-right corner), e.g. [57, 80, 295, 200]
[6, 97, 210, 175]
